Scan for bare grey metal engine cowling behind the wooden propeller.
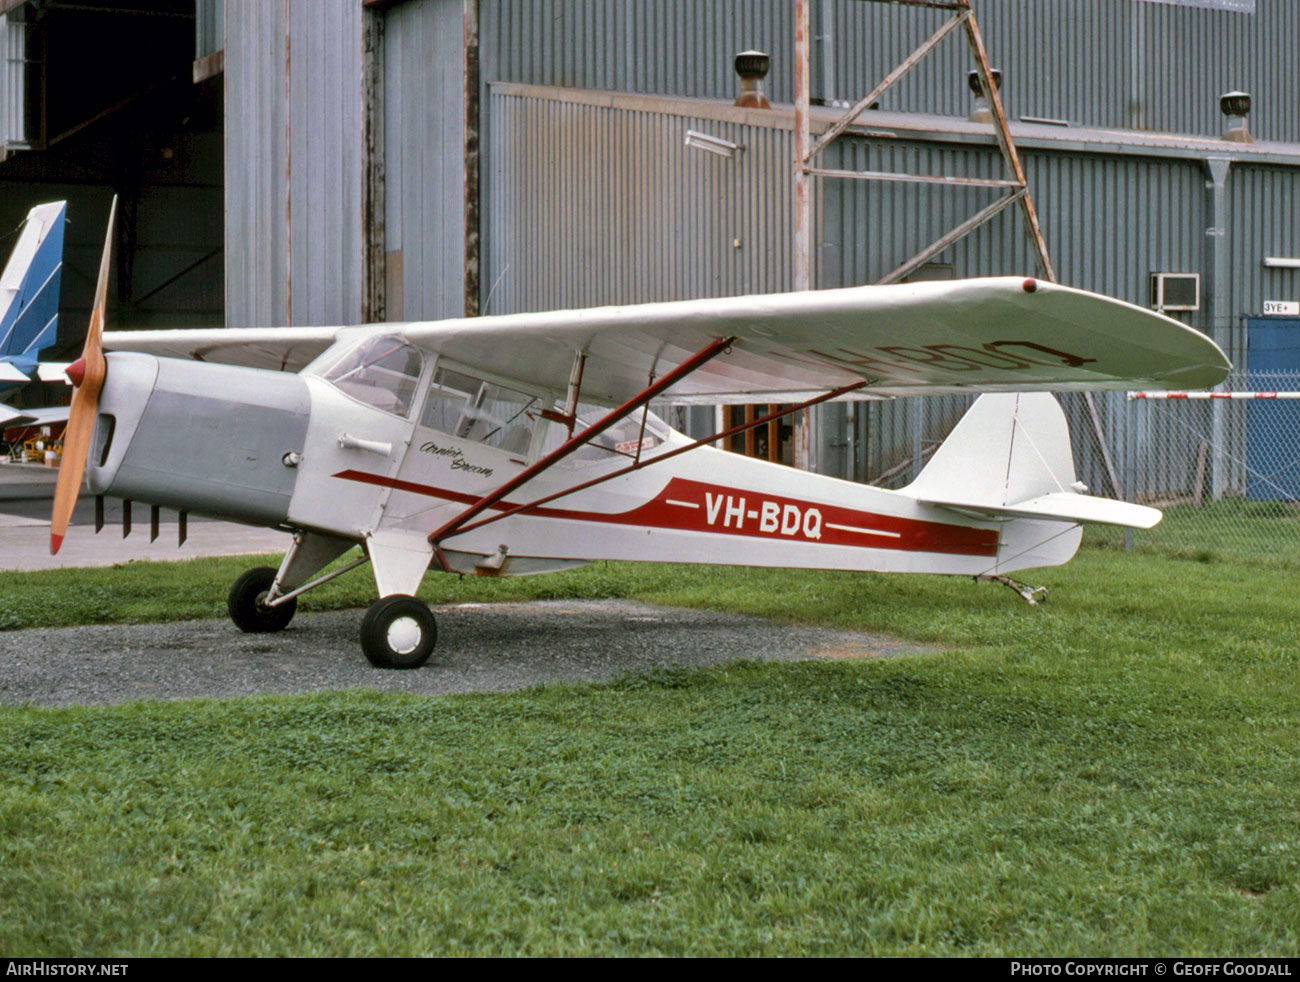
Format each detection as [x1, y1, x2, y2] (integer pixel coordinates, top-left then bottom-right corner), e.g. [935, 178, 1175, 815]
[87, 352, 311, 525]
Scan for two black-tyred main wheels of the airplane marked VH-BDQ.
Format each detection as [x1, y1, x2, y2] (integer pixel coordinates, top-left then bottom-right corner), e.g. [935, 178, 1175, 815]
[226, 566, 438, 669]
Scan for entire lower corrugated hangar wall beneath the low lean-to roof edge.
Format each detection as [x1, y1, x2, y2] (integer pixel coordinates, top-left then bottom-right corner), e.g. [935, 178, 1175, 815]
[484, 83, 1300, 493]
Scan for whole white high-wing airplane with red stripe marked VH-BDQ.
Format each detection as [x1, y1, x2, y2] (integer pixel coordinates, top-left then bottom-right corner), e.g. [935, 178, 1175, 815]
[51, 204, 1229, 669]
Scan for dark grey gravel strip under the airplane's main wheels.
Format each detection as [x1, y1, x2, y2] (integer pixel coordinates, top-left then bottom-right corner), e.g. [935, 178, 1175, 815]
[0, 600, 924, 706]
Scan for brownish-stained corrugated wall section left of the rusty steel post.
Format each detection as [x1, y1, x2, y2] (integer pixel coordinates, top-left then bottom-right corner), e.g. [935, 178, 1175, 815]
[484, 85, 793, 313]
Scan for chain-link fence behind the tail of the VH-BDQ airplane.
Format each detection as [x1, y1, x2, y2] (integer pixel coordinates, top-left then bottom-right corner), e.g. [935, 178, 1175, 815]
[858, 373, 1300, 566]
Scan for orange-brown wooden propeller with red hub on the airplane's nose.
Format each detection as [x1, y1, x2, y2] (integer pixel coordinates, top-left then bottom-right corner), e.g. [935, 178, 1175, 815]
[49, 195, 117, 555]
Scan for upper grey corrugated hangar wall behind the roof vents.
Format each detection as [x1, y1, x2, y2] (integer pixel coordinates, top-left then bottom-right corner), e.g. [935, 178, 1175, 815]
[481, 0, 1300, 142]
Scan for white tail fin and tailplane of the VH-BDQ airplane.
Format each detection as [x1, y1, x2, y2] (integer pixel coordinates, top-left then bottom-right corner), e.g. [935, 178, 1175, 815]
[904, 393, 1161, 530]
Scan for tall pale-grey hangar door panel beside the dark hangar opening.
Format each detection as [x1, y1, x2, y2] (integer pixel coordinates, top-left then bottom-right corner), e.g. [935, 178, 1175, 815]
[225, 0, 363, 326]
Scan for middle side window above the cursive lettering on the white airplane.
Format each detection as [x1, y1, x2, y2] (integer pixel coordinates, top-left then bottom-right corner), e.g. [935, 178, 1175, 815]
[420, 368, 542, 454]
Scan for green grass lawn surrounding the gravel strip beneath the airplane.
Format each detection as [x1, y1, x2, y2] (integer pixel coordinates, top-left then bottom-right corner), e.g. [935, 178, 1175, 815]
[0, 548, 1300, 956]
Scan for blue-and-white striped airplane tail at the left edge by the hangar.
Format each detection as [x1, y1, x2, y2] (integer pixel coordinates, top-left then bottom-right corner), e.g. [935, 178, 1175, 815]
[0, 202, 68, 427]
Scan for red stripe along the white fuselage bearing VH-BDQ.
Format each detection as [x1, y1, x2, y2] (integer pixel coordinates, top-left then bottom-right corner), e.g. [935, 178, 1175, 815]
[334, 471, 998, 555]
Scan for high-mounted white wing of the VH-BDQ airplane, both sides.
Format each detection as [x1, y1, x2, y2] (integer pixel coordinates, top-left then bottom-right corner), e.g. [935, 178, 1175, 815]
[104, 277, 1230, 403]
